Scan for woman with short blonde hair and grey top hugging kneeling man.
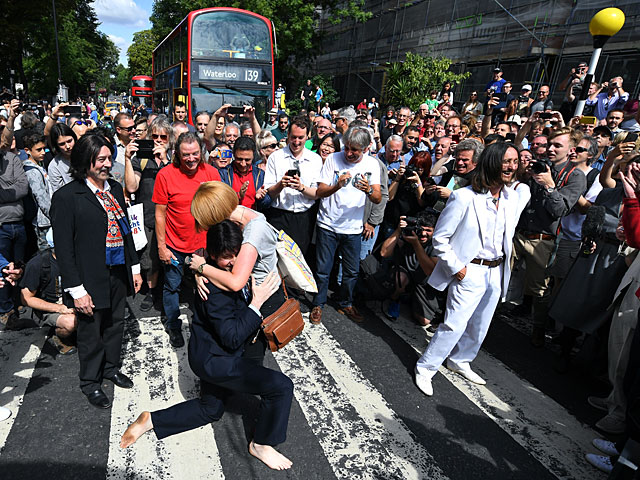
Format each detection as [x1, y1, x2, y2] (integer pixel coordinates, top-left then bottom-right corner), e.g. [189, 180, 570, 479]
[190, 182, 285, 365]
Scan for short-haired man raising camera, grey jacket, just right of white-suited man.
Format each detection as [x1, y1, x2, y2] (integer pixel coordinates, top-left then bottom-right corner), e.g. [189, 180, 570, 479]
[514, 127, 587, 347]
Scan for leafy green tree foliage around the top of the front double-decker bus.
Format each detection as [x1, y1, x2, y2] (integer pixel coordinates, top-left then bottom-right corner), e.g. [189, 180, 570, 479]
[151, 0, 371, 84]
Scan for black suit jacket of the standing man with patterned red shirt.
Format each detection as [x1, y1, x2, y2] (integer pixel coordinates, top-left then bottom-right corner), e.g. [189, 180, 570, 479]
[51, 180, 138, 308]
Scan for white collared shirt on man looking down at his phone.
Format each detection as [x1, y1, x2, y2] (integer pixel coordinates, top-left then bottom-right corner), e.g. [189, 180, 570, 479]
[264, 145, 322, 212]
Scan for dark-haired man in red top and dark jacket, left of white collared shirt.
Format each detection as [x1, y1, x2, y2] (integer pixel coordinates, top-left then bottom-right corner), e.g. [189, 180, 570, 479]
[220, 137, 271, 210]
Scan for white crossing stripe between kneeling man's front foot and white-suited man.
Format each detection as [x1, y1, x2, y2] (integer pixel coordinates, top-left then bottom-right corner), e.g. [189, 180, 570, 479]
[274, 314, 447, 480]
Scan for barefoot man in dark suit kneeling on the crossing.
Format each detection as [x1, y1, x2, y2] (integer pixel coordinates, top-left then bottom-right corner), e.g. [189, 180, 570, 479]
[120, 220, 293, 470]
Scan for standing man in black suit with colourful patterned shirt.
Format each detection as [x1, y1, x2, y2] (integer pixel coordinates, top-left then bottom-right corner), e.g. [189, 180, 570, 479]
[51, 134, 142, 408]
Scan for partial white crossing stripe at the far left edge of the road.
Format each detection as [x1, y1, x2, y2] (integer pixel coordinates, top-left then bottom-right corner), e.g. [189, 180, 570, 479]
[0, 328, 45, 454]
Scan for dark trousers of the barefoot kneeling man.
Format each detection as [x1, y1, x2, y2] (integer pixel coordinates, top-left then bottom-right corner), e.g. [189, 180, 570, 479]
[151, 357, 293, 446]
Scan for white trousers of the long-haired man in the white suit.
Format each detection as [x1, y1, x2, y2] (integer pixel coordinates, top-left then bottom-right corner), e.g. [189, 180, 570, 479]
[416, 263, 503, 376]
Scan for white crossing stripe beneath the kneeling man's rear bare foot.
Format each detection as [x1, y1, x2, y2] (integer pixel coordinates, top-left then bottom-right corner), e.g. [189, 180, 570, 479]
[106, 315, 224, 480]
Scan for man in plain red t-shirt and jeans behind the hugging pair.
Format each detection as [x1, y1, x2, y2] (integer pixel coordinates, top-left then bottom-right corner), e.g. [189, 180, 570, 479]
[151, 132, 220, 348]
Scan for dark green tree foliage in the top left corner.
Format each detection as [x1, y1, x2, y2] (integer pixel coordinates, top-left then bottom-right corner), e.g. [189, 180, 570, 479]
[0, 0, 119, 97]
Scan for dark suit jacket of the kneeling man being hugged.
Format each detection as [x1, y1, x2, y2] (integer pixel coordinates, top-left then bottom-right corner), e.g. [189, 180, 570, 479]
[189, 283, 262, 377]
